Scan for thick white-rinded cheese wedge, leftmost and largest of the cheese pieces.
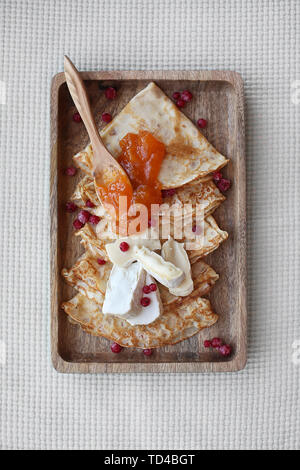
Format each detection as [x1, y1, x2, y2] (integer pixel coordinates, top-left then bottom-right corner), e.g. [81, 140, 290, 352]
[102, 262, 146, 316]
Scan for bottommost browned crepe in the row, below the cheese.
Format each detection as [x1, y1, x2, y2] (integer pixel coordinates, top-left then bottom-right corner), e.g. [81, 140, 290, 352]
[62, 294, 218, 349]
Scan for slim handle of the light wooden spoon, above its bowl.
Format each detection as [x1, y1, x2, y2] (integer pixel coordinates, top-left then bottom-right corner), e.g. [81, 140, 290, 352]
[64, 55, 104, 150]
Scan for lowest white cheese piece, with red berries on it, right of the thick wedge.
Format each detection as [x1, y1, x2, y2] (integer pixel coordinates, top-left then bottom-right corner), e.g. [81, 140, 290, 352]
[126, 273, 162, 325]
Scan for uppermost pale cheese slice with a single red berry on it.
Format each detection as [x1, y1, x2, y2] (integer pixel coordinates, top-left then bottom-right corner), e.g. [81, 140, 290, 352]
[105, 237, 161, 267]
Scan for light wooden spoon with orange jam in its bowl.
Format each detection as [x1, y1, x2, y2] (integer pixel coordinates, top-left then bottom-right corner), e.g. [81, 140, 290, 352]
[64, 56, 133, 205]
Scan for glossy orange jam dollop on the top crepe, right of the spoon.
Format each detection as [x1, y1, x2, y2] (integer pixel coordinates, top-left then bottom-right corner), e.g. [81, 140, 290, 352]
[118, 131, 166, 215]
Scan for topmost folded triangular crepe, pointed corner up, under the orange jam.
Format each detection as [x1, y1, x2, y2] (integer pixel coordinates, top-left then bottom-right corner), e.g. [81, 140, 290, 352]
[73, 82, 228, 188]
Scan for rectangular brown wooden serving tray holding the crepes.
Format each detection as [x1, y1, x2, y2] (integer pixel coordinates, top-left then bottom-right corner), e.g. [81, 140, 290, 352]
[50, 71, 247, 373]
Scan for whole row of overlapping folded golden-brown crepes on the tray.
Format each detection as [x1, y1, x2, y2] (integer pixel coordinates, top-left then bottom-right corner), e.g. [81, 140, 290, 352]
[62, 82, 228, 348]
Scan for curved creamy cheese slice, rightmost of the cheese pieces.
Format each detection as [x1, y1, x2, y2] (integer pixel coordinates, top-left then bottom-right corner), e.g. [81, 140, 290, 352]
[161, 237, 194, 297]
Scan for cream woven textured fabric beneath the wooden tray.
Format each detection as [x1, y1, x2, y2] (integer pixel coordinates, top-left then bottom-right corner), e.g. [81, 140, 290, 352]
[0, 0, 300, 449]
